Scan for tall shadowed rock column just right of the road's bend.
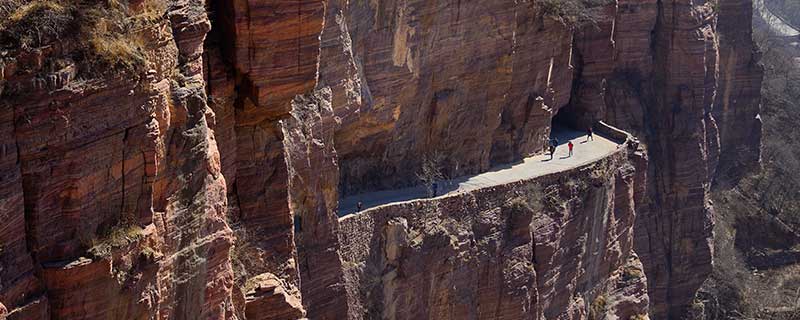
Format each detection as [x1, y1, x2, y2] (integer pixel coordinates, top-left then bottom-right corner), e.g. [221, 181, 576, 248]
[636, 1, 717, 318]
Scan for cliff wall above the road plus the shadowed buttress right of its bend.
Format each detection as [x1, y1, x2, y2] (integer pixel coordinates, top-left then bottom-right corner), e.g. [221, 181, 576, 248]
[320, 0, 761, 317]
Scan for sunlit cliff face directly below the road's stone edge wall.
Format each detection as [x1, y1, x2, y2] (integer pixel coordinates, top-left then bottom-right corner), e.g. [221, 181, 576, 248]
[341, 149, 648, 319]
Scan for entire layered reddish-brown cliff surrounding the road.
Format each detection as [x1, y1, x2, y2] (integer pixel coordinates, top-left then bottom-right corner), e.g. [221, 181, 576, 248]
[0, 0, 761, 319]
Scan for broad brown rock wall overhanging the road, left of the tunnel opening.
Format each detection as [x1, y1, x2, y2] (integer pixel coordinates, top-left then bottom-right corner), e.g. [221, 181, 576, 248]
[320, 0, 572, 195]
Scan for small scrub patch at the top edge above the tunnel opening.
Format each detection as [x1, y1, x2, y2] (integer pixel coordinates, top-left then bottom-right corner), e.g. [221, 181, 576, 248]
[536, 0, 610, 27]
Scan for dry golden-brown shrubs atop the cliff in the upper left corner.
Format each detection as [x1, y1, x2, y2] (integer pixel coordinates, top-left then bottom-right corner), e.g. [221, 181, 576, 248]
[0, 0, 167, 74]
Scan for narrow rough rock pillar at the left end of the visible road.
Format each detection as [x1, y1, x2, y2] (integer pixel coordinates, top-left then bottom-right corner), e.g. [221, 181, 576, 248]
[283, 88, 350, 319]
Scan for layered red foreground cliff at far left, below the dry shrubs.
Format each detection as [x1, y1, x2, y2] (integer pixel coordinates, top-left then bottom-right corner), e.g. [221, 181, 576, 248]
[0, 2, 233, 319]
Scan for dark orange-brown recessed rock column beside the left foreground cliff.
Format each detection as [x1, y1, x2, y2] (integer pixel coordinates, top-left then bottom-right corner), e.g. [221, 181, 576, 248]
[206, 0, 325, 296]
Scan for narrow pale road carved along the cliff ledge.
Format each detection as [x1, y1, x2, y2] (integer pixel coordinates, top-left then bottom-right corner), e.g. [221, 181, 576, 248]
[338, 127, 620, 217]
